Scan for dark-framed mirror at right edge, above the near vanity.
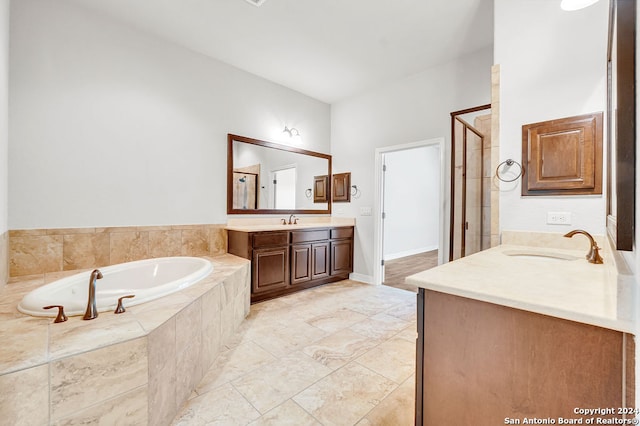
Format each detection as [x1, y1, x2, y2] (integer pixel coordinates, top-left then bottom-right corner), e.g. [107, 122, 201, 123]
[607, 0, 636, 251]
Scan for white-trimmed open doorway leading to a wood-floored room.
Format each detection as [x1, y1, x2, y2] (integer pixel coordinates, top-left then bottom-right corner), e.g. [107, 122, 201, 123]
[374, 138, 445, 284]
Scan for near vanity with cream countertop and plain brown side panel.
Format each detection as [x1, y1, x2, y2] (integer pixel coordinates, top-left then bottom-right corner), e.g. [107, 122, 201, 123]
[407, 234, 637, 425]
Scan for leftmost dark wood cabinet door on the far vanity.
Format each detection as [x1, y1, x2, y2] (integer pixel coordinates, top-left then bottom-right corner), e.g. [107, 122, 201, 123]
[252, 246, 289, 293]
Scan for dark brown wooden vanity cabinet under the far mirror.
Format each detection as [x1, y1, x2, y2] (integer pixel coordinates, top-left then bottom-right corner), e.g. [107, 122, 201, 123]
[228, 226, 354, 303]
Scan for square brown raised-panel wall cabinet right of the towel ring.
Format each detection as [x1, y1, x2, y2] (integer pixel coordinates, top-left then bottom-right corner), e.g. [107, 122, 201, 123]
[522, 112, 602, 195]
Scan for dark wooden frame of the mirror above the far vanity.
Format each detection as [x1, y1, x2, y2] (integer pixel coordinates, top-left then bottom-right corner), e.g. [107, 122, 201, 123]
[227, 133, 331, 214]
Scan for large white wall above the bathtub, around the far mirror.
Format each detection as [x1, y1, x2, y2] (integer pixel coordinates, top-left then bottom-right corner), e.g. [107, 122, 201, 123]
[8, 0, 331, 229]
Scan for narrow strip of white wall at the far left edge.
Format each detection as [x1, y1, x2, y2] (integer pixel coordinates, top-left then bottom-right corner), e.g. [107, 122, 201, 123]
[0, 0, 9, 235]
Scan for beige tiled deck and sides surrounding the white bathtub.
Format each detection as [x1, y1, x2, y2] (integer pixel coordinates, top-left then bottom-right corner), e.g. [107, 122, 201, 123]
[0, 254, 250, 425]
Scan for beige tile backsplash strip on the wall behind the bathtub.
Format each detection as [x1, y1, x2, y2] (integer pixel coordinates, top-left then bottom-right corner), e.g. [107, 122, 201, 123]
[8, 225, 227, 278]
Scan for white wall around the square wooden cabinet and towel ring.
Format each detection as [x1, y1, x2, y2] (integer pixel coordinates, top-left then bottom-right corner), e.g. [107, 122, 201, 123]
[494, 0, 608, 235]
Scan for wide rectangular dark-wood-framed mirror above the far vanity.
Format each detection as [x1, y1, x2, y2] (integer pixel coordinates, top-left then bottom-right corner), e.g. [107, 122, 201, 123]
[227, 134, 331, 214]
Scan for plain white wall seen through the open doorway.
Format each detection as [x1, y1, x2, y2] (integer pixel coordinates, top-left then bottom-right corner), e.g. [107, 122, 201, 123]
[383, 145, 440, 260]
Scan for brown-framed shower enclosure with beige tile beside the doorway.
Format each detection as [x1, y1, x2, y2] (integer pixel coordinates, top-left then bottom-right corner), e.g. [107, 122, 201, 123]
[449, 105, 493, 261]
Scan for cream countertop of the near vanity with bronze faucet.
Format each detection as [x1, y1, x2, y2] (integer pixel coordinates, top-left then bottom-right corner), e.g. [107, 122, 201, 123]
[406, 244, 635, 333]
